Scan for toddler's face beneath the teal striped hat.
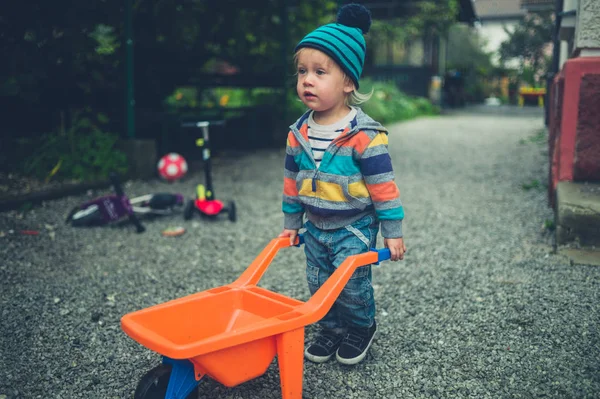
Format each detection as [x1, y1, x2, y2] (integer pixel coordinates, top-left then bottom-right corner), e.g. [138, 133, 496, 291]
[296, 48, 354, 112]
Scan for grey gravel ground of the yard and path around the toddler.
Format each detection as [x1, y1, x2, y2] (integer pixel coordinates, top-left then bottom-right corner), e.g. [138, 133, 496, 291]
[0, 108, 600, 399]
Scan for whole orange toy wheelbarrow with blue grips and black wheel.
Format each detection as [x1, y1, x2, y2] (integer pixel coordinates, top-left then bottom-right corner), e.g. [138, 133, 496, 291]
[121, 236, 390, 399]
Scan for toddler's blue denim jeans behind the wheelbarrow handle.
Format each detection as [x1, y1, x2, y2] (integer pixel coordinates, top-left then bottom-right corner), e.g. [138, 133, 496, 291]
[304, 216, 379, 333]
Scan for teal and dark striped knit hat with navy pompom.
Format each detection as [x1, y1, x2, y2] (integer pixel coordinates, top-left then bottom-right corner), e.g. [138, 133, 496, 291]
[294, 4, 371, 89]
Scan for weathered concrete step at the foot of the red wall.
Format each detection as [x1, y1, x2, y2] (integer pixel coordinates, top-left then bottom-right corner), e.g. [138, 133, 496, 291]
[556, 182, 600, 249]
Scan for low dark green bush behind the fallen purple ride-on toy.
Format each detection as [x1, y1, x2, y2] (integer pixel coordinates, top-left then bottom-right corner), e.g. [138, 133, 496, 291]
[19, 113, 127, 181]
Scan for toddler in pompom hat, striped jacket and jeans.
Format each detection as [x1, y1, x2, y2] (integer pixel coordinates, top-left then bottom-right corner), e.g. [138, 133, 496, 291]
[280, 4, 406, 365]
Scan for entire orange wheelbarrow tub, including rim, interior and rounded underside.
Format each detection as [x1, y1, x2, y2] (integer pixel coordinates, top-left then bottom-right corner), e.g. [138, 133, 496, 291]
[122, 286, 309, 387]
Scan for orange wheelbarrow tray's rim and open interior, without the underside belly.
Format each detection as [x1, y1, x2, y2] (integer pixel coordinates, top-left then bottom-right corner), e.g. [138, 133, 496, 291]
[121, 286, 305, 359]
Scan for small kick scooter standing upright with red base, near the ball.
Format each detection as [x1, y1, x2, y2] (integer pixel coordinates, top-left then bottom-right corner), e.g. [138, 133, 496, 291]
[181, 121, 236, 222]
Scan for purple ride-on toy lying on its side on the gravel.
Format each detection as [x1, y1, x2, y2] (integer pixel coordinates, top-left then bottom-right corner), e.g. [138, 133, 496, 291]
[66, 173, 184, 233]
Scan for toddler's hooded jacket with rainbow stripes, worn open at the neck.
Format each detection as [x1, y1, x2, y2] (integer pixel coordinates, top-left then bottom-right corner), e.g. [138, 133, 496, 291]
[282, 109, 404, 238]
